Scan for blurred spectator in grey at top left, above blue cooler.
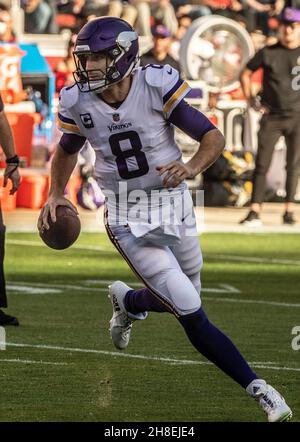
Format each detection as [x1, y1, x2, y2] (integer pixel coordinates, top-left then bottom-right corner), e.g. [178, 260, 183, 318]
[23, 0, 57, 34]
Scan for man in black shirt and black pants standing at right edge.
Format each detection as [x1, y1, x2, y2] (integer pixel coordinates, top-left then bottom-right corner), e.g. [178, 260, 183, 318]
[241, 8, 300, 225]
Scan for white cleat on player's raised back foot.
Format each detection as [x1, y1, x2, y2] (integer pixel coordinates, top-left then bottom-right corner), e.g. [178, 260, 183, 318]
[108, 281, 148, 350]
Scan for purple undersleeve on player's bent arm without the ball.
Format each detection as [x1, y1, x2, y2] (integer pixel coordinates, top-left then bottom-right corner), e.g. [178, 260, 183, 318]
[168, 100, 216, 141]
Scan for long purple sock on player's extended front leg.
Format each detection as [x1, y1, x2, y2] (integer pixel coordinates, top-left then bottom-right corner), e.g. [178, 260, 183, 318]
[179, 308, 258, 388]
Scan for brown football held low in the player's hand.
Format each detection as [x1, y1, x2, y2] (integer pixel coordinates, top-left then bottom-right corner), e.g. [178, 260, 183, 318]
[40, 206, 81, 250]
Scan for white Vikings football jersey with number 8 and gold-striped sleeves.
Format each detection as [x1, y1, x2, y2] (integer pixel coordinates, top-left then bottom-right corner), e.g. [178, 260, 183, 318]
[58, 65, 190, 193]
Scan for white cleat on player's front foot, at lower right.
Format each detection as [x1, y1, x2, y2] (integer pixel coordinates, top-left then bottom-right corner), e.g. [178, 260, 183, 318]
[246, 379, 293, 422]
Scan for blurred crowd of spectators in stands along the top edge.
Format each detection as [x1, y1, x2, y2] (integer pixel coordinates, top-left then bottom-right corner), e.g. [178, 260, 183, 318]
[0, 0, 300, 38]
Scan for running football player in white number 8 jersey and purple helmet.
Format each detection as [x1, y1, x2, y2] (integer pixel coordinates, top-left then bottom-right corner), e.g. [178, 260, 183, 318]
[38, 17, 292, 422]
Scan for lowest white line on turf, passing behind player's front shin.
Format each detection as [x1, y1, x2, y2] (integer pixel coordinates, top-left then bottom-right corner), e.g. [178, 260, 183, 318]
[6, 342, 300, 372]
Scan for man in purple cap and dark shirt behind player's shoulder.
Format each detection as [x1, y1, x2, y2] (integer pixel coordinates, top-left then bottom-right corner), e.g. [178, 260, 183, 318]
[141, 25, 180, 72]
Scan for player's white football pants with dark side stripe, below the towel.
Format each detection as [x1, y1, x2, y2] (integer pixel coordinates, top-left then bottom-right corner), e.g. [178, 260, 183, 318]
[105, 212, 202, 317]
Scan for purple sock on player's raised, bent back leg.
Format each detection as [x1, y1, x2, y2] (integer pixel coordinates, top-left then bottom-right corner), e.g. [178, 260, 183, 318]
[124, 288, 170, 315]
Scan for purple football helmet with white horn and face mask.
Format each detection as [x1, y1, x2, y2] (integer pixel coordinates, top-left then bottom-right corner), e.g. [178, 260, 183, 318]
[73, 17, 139, 92]
